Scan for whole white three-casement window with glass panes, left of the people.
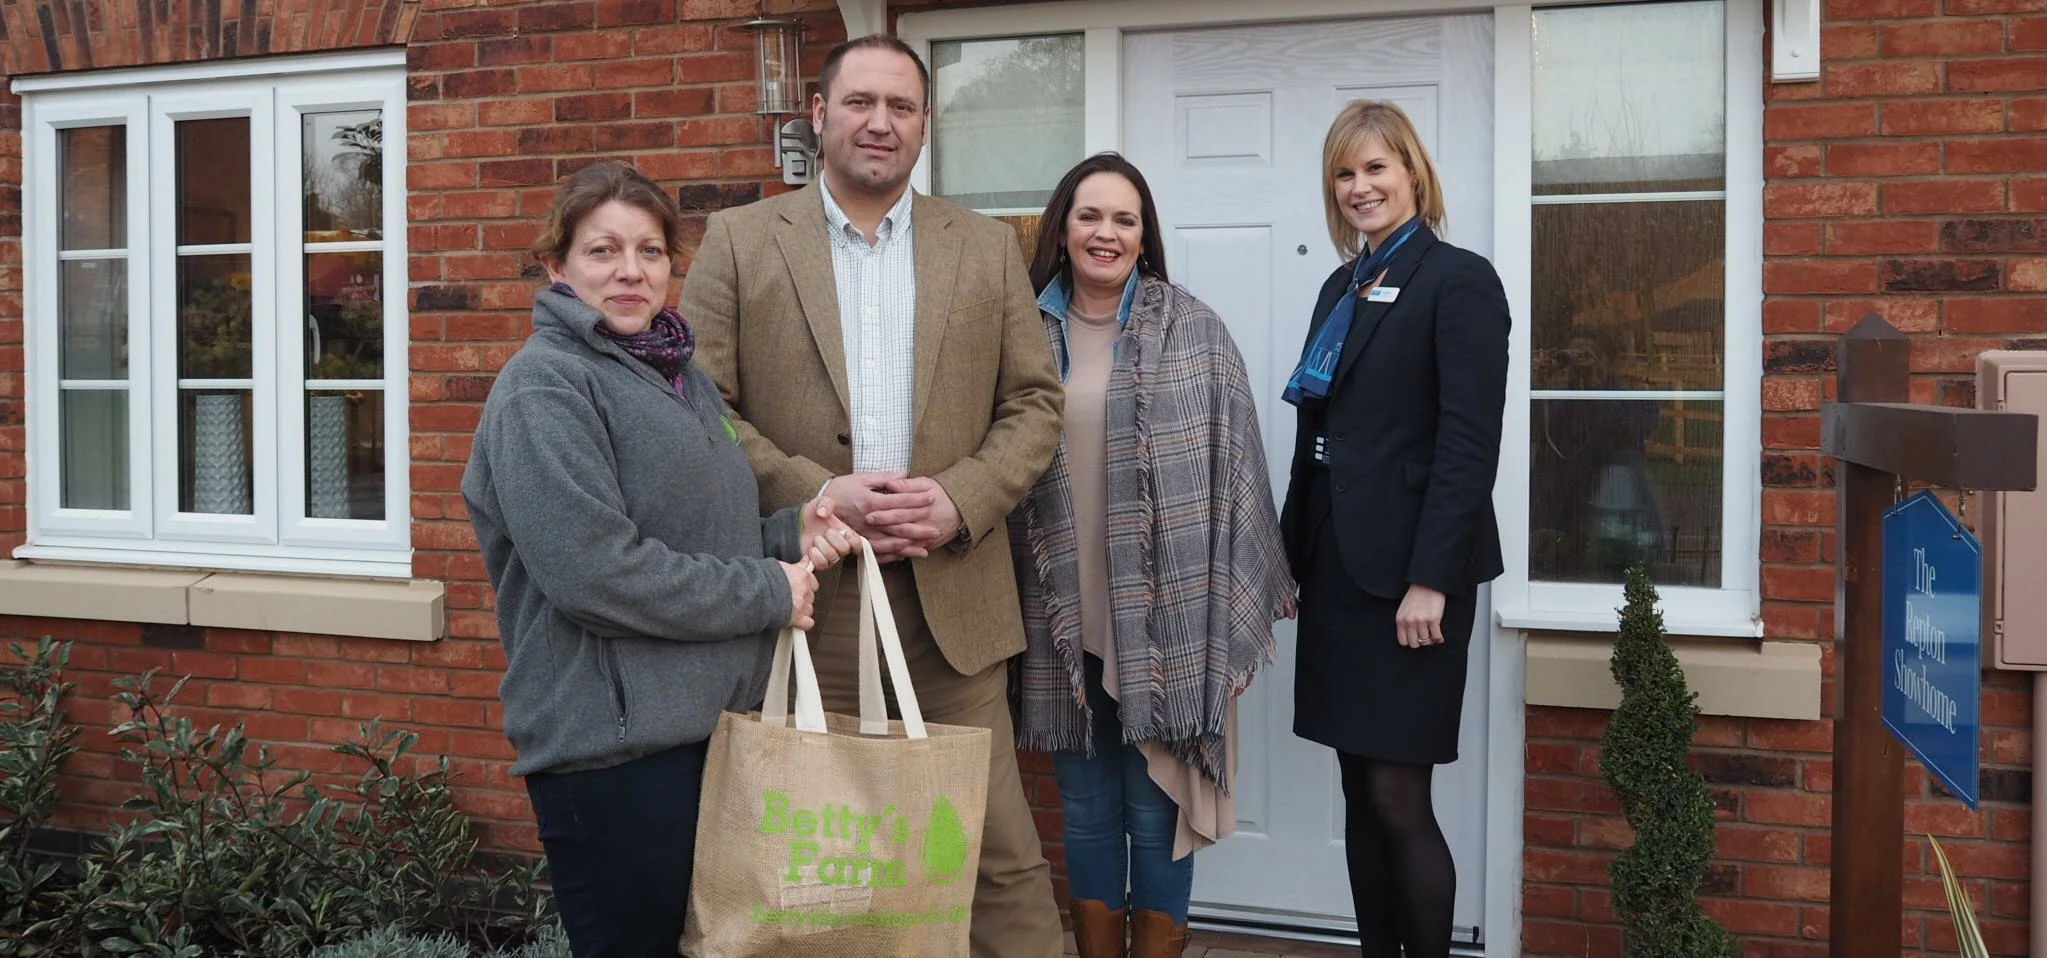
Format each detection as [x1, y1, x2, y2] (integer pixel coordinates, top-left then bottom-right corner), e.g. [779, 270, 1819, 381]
[14, 51, 411, 575]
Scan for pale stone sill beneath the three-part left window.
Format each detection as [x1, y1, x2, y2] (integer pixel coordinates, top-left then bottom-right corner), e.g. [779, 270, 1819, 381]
[0, 561, 446, 643]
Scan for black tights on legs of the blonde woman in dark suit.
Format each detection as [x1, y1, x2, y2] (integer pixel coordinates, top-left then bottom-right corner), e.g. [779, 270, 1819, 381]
[1337, 751, 1457, 958]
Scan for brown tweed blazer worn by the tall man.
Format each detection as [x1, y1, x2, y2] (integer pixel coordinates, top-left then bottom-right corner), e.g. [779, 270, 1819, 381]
[682, 184, 1064, 676]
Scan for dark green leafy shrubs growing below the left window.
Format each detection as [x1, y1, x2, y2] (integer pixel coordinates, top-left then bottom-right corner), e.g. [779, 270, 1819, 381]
[0, 643, 545, 958]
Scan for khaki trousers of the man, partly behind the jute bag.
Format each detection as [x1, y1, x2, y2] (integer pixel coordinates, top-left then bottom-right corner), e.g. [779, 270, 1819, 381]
[811, 563, 1064, 958]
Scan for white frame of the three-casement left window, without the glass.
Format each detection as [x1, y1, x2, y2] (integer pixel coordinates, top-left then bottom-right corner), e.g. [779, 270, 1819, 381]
[14, 51, 411, 577]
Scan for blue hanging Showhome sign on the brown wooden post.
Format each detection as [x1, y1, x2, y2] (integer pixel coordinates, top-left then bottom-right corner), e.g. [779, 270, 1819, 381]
[1883, 491, 1984, 809]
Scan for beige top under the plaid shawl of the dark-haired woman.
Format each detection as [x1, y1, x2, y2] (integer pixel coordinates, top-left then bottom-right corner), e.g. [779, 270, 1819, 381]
[1066, 307, 1236, 860]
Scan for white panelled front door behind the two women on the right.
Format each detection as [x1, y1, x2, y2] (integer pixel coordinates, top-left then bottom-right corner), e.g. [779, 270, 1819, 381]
[1122, 14, 1492, 944]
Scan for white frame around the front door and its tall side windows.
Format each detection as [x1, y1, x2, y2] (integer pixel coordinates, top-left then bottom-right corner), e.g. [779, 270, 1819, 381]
[897, 0, 1765, 639]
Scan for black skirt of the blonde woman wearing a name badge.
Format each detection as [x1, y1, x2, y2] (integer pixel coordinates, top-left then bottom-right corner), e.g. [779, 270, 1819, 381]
[1294, 469, 1478, 766]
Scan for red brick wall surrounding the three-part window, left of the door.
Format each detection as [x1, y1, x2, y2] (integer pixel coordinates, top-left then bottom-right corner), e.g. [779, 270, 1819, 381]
[0, 0, 1058, 884]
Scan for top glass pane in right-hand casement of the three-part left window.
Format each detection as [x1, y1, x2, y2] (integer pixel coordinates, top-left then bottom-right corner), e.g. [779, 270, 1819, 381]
[301, 111, 383, 244]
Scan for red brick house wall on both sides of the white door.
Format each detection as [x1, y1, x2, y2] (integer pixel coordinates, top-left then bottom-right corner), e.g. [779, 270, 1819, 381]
[0, 0, 2047, 956]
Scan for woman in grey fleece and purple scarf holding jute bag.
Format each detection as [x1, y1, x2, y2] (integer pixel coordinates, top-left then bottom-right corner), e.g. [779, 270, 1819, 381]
[463, 164, 856, 958]
